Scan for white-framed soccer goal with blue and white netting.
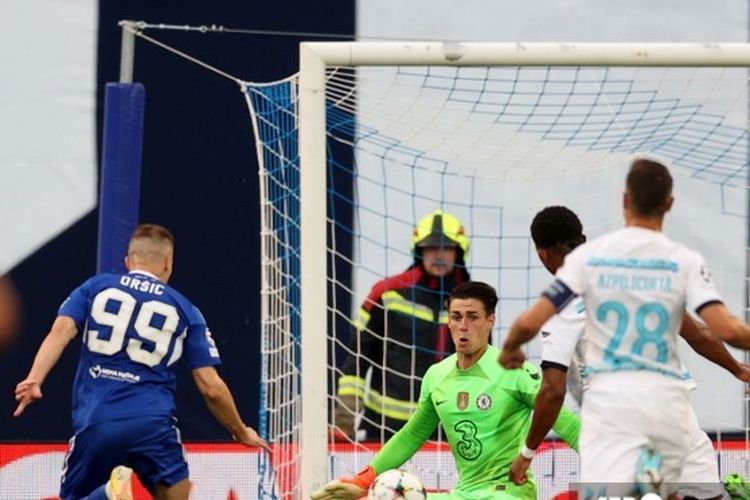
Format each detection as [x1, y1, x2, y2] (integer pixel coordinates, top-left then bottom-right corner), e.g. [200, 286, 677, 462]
[245, 42, 750, 498]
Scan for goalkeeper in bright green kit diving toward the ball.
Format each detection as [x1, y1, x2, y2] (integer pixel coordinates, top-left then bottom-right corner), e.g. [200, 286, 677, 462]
[311, 281, 581, 500]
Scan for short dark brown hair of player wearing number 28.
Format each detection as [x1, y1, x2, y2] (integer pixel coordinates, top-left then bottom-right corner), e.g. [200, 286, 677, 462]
[625, 158, 672, 217]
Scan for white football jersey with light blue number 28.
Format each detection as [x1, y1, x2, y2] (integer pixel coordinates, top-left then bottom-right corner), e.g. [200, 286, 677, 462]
[545, 227, 721, 379]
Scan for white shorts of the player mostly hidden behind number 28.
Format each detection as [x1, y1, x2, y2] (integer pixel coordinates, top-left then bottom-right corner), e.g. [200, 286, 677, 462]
[679, 406, 724, 498]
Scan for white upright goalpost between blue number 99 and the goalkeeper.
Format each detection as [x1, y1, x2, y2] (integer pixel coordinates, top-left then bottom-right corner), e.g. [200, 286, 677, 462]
[299, 43, 328, 498]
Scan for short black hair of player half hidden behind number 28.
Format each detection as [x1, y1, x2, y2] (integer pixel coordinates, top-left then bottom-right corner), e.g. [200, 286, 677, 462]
[531, 205, 586, 253]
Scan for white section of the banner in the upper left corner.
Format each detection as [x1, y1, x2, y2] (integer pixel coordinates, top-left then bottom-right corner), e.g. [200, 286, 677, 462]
[0, 0, 98, 274]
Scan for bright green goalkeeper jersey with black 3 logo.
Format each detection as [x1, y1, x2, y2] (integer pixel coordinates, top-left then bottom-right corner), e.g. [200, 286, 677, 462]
[370, 346, 581, 499]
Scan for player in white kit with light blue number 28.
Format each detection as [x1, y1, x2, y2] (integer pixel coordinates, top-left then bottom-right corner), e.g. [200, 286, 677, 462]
[501, 159, 750, 496]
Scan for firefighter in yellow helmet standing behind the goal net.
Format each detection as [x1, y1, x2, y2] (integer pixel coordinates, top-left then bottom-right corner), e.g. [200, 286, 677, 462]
[333, 210, 469, 442]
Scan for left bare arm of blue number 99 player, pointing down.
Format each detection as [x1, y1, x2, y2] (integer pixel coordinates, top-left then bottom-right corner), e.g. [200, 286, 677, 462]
[13, 316, 78, 417]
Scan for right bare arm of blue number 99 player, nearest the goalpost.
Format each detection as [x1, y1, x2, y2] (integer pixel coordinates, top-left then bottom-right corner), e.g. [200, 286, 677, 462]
[193, 366, 271, 453]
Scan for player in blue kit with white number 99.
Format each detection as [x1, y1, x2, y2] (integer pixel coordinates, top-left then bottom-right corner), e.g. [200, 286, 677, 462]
[14, 224, 270, 500]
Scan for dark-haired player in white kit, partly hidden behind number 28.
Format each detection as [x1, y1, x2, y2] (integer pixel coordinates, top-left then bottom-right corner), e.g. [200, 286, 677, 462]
[510, 206, 750, 499]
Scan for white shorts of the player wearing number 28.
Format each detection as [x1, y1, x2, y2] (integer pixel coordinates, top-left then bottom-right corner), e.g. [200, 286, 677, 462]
[580, 371, 692, 497]
